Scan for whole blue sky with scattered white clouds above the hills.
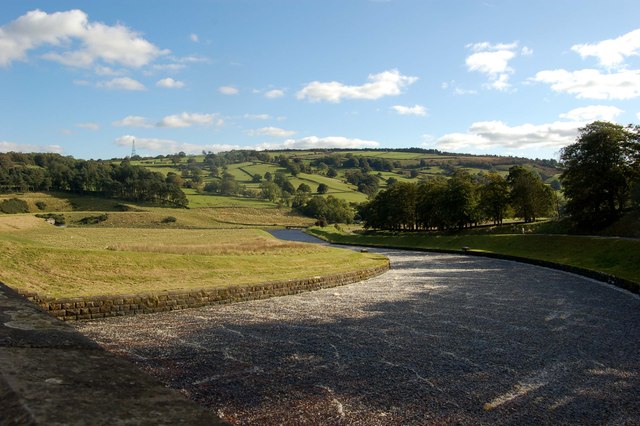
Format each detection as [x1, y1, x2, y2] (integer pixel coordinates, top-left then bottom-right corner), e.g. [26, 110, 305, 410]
[0, 0, 640, 159]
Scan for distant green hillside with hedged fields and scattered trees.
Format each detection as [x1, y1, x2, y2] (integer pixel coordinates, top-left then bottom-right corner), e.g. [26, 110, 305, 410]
[131, 148, 561, 207]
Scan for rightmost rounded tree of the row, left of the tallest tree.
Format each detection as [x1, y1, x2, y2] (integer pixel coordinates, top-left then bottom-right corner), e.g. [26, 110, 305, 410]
[507, 166, 554, 222]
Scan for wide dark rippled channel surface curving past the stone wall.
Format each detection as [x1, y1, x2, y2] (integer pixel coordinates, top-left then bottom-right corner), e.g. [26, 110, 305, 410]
[77, 250, 640, 425]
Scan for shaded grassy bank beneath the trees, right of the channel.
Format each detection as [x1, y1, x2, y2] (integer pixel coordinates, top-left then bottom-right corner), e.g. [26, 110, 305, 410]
[310, 227, 640, 283]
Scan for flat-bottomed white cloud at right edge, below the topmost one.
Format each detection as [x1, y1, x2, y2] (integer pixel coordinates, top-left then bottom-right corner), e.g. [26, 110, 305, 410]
[532, 69, 640, 100]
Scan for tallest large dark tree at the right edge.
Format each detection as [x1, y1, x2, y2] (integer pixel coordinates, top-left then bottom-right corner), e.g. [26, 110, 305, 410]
[560, 121, 640, 229]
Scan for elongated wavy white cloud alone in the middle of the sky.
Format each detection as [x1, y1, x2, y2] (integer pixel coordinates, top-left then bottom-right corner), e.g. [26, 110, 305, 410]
[296, 70, 418, 102]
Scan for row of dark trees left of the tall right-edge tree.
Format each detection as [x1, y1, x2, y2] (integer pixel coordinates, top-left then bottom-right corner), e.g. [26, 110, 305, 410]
[360, 166, 556, 231]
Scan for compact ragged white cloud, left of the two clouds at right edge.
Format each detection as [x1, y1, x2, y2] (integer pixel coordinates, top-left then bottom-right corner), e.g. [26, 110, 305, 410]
[465, 42, 532, 91]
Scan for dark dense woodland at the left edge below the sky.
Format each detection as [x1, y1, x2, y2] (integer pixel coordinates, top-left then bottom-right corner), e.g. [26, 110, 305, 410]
[0, 152, 188, 207]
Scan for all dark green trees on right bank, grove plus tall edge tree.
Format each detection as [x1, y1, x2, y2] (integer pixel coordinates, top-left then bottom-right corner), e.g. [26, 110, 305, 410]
[360, 121, 640, 231]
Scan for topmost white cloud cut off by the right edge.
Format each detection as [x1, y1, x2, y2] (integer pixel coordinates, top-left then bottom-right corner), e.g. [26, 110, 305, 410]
[571, 29, 640, 68]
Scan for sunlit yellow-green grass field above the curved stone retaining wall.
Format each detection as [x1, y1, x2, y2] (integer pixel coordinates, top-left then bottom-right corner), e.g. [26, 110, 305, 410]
[0, 221, 385, 297]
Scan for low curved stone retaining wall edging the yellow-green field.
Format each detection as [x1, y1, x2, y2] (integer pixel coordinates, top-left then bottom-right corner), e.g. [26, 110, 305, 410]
[21, 261, 389, 321]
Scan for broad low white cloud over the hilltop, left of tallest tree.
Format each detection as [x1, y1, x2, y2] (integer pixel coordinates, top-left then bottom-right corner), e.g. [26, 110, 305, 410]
[437, 121, 585, 151]
